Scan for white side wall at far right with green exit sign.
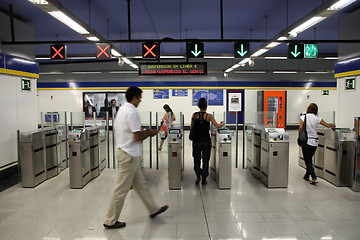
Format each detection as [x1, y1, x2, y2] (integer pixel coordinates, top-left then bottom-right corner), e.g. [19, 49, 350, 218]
[336, 76, 360, 129]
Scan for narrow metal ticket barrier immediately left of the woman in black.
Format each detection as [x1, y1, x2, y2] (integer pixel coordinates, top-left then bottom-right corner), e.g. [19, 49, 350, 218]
[168, 126, 183, 190]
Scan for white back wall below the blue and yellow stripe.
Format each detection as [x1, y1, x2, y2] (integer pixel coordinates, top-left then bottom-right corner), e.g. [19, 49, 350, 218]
[37, 89, 337, 125]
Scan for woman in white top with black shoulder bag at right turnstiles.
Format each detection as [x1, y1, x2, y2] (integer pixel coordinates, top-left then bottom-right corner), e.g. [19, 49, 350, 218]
[299, 103, 335, 185]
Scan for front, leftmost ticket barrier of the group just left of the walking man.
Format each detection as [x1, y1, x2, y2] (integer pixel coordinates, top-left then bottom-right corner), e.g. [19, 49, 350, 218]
[69, 128, 91, 188]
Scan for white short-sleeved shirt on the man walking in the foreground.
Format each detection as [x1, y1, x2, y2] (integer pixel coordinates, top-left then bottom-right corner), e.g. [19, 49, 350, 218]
[114, 102, 141, 157]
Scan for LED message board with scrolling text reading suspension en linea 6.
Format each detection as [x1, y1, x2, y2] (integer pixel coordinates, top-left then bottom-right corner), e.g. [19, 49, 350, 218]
[139, 62, 207, 75]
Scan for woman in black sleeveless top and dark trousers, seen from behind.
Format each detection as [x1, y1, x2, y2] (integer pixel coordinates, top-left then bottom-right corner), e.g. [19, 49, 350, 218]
[190, 98, 225, 184]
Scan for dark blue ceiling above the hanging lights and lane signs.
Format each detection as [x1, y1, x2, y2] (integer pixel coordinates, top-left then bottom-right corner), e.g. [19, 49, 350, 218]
[0, 0, 360, 75]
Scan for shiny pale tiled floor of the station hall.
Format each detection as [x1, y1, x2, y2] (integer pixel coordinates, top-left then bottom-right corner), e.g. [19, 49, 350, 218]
[0, 131, 360, 240]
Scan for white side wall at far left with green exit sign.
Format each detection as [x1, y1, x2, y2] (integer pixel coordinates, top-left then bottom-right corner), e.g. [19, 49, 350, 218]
[0, 75, 37, 167]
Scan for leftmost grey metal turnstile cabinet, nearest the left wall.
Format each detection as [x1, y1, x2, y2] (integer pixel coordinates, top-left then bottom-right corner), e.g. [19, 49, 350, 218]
[20, 131, 46, 187]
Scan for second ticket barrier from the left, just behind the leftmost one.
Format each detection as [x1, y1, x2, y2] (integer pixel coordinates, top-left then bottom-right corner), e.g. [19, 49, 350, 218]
[42, 127, 61, 179]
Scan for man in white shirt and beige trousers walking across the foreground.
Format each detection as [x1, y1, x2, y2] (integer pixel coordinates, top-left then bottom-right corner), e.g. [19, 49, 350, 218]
[104, 87, 168, 229]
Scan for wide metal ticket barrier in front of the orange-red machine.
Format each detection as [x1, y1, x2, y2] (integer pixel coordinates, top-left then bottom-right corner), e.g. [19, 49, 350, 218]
[260, 128, 289, 188]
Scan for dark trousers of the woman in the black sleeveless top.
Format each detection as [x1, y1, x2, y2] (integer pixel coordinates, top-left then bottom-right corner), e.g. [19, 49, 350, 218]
[193, 141, 211, 181]
